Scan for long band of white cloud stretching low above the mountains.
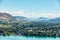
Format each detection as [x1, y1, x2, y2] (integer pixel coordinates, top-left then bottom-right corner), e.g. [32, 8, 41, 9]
[0, 10, 60, 18]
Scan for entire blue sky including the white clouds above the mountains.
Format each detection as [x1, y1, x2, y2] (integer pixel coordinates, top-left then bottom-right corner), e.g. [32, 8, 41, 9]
[0, 0, 60, 18]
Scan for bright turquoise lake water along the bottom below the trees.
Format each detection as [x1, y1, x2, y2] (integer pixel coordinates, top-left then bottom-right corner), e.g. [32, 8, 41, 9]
[0, 36, 60, 40]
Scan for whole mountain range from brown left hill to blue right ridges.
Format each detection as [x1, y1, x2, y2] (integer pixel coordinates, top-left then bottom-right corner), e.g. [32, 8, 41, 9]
[0, 12, 60, 23]
